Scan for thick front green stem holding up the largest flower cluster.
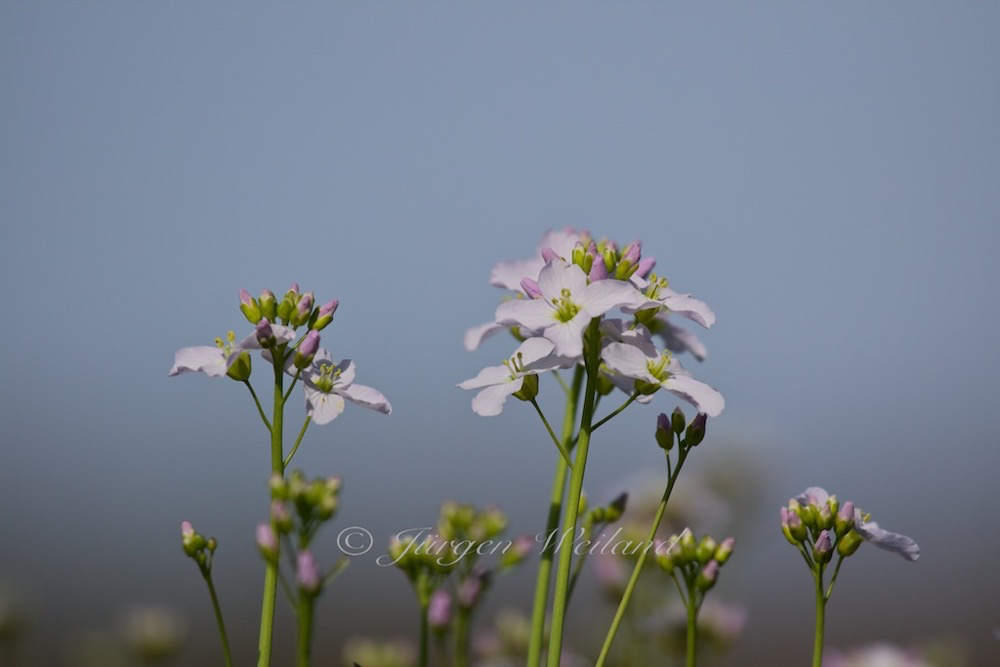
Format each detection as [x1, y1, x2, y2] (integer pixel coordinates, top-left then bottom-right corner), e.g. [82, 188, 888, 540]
[548, 317, 601, 667]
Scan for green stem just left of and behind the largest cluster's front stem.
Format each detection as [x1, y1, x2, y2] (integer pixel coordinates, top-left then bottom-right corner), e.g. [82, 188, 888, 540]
[528, 376, 583, 667]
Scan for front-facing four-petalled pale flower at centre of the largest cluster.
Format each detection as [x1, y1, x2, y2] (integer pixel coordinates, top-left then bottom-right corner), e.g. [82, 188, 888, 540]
[496, 260, 650, 357]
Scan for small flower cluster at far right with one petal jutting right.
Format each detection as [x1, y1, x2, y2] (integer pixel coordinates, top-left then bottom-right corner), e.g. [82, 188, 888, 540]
[781, 486, 920, 563]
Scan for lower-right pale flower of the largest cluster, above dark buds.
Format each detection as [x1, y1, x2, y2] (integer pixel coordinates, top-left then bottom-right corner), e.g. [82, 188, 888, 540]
[601, 343, 726, 417]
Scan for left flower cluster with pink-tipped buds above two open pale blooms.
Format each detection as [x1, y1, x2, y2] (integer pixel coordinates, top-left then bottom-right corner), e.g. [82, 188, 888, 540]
[170, 283, 392, 424]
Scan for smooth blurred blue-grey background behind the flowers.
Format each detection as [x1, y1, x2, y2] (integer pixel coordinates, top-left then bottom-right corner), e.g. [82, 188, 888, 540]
[0, 2, 1000, 665]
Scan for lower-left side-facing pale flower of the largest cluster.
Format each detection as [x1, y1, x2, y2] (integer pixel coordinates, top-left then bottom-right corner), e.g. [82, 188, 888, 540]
[458, 338, 574, 417]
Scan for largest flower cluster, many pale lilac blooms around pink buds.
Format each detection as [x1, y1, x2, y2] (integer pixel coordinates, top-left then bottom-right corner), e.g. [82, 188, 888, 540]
[459, 230, 725, 416]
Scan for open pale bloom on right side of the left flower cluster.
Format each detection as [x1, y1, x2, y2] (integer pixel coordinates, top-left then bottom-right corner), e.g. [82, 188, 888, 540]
[300, 348, 392, 424]
